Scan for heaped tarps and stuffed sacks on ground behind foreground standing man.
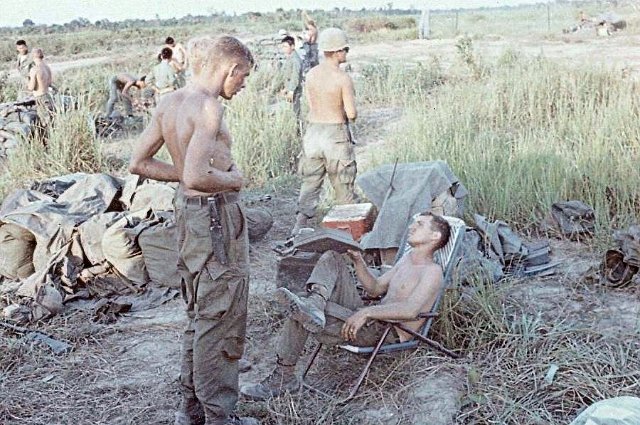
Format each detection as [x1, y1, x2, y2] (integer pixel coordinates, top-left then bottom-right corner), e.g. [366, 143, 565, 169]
[0, 173, 273, 321]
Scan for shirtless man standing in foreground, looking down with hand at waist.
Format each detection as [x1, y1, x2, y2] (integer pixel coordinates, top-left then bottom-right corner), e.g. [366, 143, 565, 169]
[129, 37, 259, 425]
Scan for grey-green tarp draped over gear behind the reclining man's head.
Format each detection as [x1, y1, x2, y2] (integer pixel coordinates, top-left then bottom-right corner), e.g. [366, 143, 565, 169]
[356, 161, 467, 249]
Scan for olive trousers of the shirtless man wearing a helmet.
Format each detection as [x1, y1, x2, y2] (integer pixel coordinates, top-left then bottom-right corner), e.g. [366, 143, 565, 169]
[298, 123, 357, 218]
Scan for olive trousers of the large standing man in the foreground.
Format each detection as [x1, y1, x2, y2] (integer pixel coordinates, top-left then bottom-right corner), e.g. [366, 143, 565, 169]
[175, 189, 249, 424]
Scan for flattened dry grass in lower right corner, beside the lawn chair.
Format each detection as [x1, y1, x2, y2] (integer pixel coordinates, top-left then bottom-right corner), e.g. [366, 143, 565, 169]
[434, 282, 640, 424]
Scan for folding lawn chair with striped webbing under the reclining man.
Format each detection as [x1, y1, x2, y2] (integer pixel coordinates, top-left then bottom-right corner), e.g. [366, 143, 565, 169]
[302, 216, 466, 403]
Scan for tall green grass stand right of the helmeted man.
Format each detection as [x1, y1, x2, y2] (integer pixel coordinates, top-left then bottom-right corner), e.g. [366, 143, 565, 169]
[364, 54, 640, 237]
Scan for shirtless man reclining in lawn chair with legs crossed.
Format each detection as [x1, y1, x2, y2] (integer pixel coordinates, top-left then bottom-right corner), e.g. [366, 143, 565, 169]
[241, 213, 450, 400]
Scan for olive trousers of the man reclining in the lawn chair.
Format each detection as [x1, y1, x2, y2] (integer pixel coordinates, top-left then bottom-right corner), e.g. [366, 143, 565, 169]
[277, 251, 397, 366]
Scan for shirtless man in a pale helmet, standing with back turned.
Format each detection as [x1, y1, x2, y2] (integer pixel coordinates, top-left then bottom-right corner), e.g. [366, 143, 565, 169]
[291, 28, 356, 235]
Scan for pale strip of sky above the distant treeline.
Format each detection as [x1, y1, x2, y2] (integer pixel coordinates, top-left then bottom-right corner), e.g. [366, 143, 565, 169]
[0, 0, 544, 26]
